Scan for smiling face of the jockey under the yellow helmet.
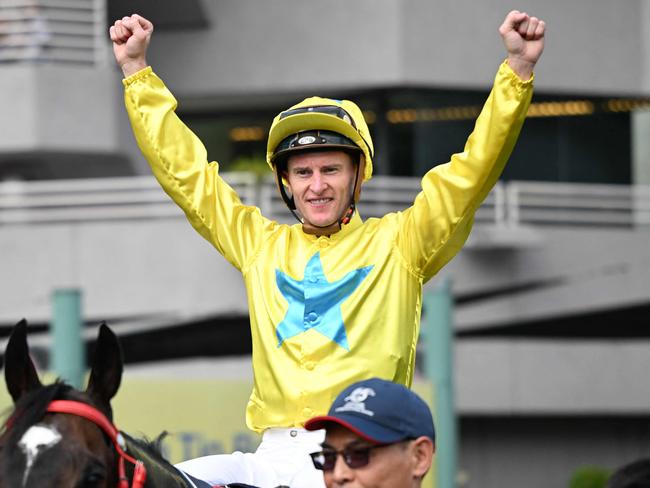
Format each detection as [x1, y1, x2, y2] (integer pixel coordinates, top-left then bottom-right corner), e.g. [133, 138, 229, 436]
[285, 151, 356, 235]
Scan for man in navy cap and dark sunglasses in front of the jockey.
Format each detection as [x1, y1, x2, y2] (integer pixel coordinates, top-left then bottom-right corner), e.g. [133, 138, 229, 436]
[305, 378, 436, 488]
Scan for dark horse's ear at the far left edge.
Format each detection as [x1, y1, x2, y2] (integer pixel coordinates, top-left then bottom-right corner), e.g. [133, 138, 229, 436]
[5, 319, 42, 403]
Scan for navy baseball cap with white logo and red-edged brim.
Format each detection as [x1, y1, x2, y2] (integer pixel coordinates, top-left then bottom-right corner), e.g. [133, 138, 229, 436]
[305, 378, 436, 444]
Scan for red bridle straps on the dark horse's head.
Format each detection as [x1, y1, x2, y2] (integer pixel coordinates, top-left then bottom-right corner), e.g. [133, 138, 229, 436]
[47, 400, 147, 488]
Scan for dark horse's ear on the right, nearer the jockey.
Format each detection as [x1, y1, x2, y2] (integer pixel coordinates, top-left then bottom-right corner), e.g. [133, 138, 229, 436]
[86, 322, 122, 412]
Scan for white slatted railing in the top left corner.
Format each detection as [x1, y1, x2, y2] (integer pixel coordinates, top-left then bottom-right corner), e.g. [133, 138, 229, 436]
[0, 0, 107, 65]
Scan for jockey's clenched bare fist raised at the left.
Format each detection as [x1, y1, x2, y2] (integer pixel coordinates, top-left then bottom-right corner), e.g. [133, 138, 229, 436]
[109, 14, 153, 78]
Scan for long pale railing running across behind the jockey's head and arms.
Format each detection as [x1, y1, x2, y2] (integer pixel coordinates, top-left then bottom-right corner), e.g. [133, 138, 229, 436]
[0, 173, 650, 228]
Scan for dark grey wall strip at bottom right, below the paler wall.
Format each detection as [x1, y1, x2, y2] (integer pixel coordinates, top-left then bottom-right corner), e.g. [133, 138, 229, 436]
[459, 416, 650, 488]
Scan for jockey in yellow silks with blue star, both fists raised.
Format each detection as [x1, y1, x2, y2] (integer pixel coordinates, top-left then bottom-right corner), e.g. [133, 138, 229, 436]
[110, 11, 545, 488]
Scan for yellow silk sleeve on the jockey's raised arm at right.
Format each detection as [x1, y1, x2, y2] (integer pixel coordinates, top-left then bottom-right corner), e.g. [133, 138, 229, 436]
[396, 62, 533, 281]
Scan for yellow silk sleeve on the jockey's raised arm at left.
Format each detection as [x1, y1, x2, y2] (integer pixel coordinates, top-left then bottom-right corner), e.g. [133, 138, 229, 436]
[124, 67, 271, 270]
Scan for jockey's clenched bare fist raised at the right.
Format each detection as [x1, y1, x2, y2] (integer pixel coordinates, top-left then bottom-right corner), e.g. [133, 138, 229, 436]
[499, 10, 546, 80]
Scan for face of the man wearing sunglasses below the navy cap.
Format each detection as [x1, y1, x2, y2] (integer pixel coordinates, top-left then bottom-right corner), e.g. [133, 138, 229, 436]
[323, 424, 433, 488]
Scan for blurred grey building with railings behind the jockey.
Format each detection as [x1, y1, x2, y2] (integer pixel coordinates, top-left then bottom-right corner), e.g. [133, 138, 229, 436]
[0, 0, 650, 488]
